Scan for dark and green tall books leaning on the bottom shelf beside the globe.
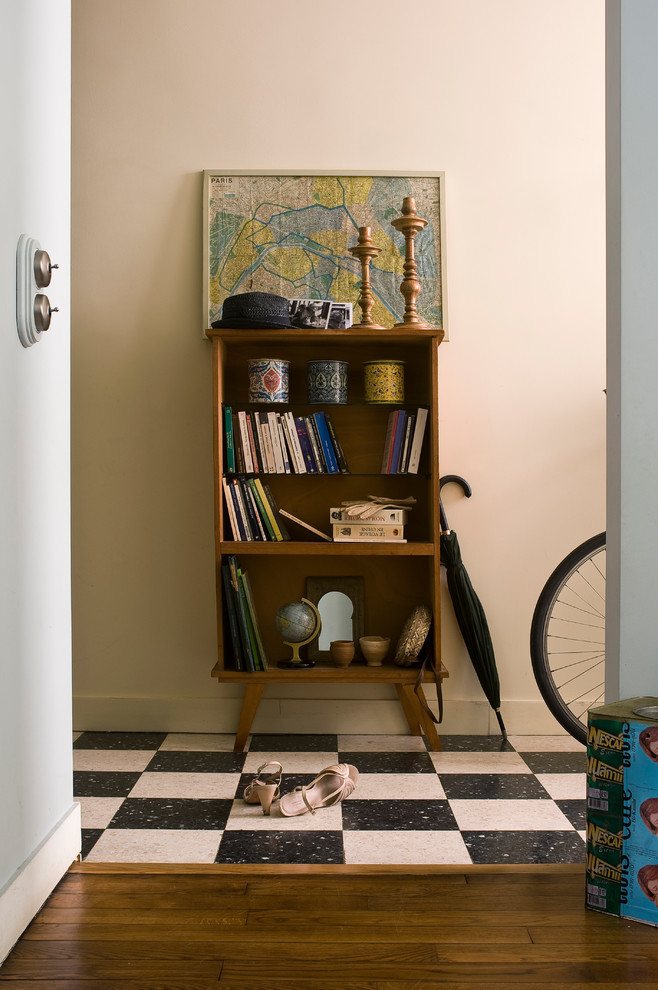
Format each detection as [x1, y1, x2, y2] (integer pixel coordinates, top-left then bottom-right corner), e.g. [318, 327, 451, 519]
[222, 556, 268, 671]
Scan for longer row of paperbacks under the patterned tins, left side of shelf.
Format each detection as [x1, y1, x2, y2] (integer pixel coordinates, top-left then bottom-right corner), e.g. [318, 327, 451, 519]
[224, 406, 349, 474]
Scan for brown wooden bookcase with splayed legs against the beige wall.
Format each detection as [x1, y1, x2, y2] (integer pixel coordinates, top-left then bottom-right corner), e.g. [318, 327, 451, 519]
[207, 327, 447, 751]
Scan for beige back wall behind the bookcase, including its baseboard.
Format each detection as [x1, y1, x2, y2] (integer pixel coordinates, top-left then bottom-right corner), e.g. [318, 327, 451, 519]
[72, 0, 605, 732]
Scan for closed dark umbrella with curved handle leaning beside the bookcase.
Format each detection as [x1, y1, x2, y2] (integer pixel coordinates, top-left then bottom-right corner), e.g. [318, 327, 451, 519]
[439, 474, 507, 740]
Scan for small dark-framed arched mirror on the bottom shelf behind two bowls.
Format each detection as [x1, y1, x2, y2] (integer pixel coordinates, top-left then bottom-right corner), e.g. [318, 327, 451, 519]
[306, 576, 364, 663]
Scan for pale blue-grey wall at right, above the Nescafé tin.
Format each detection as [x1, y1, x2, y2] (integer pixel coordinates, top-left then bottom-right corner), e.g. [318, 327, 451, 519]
[606, 0, 658, 699]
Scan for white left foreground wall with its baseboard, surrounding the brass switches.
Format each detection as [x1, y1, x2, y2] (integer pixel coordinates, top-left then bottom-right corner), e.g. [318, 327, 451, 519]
[0, 0, 80, 960]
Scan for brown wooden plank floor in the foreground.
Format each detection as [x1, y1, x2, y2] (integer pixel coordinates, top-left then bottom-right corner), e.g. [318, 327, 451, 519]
[0, 864, 658, 990]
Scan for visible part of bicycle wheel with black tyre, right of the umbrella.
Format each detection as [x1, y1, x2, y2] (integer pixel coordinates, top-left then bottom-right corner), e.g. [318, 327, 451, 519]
[530, 533, 606, 743]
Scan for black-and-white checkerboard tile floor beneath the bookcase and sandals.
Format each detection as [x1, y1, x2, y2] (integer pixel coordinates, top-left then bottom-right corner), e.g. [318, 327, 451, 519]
[73, 732, 586, 865]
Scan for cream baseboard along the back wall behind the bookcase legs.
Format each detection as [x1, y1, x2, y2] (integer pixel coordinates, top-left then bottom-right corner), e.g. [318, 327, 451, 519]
[73, 685, 563, 735]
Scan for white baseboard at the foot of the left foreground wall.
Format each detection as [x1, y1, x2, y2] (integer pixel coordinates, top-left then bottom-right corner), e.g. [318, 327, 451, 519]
[0, 804, 80, 963]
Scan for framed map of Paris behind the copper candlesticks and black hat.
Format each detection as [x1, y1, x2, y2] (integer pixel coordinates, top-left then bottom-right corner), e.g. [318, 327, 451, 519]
[202, 170, 448, 340]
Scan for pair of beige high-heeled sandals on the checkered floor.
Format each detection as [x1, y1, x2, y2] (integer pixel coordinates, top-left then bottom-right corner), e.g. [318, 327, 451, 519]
[243, 760, 359, 818]
